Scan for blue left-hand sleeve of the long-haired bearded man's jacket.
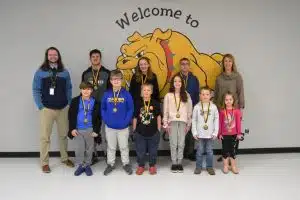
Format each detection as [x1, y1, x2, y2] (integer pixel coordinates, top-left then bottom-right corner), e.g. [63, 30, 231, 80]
[32, 71, 44, 110]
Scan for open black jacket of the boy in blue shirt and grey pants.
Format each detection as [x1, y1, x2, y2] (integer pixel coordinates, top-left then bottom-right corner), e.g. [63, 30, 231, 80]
[68, 96, 101, 143]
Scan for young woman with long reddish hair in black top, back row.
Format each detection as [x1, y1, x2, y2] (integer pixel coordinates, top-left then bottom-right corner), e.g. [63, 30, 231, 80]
[129, 57, 159, 105]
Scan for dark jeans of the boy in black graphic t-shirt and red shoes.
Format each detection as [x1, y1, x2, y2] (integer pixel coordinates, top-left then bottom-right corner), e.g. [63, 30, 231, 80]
[135, 133, 160, 167]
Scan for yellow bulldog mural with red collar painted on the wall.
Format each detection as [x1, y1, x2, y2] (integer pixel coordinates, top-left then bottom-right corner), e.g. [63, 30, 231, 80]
[117, 28, 223, 98]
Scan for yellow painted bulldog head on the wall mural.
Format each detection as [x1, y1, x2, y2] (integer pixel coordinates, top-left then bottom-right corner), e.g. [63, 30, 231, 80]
[117, 29, 172, 94]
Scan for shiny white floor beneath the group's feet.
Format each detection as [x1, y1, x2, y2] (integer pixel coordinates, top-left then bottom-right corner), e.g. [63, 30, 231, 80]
[0, 153, 300, 200]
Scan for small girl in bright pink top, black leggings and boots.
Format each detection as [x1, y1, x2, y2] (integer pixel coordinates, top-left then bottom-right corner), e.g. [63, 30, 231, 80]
[218, 92, 242, 174]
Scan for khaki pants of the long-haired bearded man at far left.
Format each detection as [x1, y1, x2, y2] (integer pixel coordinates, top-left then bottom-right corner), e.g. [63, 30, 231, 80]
[40, 106, 69, 166]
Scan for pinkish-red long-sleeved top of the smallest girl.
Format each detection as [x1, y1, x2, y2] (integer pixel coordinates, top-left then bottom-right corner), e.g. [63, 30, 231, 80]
[219, 109, 242, 136]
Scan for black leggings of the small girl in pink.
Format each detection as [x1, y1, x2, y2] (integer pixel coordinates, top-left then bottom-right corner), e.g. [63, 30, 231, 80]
[222, 135, 239, 159]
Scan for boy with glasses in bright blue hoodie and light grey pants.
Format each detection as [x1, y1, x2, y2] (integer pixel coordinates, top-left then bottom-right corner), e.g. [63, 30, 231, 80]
[101, 70, 134, 176]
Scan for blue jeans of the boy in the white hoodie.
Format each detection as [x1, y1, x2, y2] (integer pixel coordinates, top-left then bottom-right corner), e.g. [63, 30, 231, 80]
[196, 139, 214, 168]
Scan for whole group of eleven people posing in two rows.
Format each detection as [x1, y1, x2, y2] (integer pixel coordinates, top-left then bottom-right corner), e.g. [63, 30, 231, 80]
[33, 47, 244, 176]
